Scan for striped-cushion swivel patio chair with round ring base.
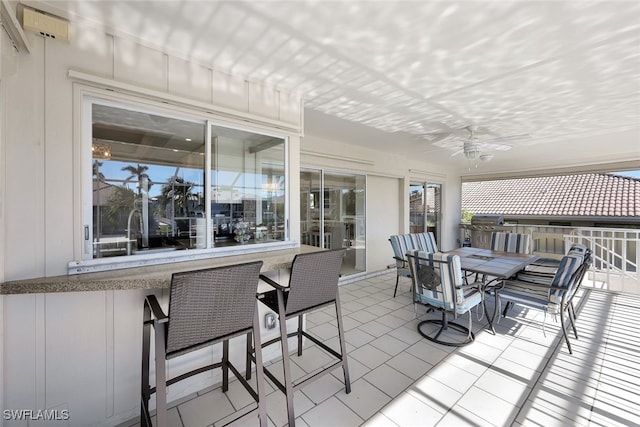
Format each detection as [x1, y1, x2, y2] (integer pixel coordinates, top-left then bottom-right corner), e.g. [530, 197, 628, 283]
[407, 250, 491, 347]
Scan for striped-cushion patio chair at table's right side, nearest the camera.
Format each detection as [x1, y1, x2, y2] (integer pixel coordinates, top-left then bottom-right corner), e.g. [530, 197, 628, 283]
[496, 251, 591, 354]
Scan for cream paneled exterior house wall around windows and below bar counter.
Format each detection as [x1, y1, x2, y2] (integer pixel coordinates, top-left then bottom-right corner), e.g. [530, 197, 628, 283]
[0, 13, 460, 426]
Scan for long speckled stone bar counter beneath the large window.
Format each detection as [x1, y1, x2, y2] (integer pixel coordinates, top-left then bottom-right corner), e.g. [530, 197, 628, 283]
[0, 245, 318, 295]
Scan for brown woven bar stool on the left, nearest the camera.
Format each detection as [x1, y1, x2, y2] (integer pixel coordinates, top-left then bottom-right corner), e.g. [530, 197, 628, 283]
[140, 261, 267, 427]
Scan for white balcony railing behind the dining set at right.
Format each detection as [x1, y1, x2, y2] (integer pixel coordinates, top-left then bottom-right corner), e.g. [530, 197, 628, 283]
[462, 224, 640, 295]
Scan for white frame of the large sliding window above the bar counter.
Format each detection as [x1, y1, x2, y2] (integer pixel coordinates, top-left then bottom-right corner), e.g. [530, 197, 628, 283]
[68, 87, 297, 274]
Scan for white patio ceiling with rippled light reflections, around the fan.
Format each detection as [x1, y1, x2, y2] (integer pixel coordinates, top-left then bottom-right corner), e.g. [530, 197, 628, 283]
[24, 0, 640, 174]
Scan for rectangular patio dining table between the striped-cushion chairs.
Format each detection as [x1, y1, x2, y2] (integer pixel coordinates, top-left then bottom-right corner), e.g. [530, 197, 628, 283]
[447, 247, 538, 333]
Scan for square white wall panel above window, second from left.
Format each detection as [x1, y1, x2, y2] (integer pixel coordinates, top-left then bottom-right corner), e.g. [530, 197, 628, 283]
[113, 37, 168, 91]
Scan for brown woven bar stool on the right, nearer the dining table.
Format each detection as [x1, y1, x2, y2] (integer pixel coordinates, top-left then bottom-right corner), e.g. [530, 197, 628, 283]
[250, 248, 351, 427]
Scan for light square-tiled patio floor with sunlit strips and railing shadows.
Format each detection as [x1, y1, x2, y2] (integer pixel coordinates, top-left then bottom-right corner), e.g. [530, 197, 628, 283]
[122, 274, 640, 427]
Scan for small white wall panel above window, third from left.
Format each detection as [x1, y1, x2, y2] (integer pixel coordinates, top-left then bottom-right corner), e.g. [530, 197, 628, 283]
[168, 57, 213, 103]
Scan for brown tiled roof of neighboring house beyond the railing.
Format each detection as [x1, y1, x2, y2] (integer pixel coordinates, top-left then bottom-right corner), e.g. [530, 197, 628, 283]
[462, 173, 640, 220]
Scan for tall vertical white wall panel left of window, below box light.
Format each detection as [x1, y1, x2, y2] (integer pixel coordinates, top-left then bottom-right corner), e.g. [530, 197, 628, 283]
[2, 37, 46, 280]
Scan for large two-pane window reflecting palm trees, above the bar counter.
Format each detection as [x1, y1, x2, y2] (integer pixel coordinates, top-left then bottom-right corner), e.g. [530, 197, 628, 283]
[85, 99, 288, 259]
